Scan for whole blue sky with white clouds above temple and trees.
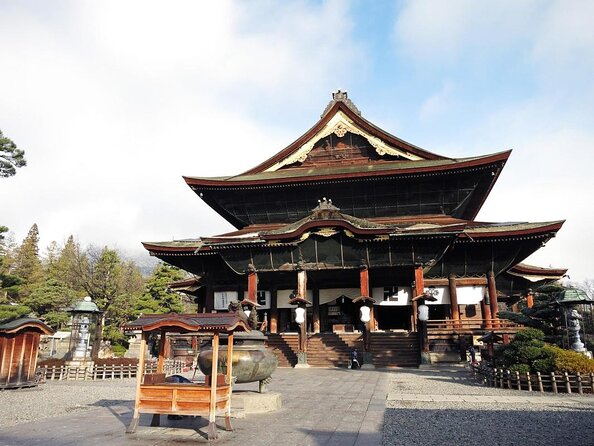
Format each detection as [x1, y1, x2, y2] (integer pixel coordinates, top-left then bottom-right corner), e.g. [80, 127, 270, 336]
[0, 0, 594, 281]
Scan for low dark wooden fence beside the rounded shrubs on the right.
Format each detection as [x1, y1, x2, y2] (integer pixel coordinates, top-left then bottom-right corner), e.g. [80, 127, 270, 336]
[471, 365, 594, 394]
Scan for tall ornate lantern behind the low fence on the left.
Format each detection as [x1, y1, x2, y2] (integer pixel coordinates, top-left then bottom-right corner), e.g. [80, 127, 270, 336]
[68, 296, 101, 366]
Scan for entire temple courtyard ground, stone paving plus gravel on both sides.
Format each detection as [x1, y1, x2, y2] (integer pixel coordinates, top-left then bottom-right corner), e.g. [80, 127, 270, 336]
[0, 366, 594, 446]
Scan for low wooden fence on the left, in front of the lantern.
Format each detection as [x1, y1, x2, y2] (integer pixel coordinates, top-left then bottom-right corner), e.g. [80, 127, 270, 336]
[36, 360, 185, 381]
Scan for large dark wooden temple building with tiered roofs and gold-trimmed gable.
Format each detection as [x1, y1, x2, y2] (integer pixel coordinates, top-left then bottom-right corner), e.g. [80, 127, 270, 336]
[144, 91, 566, 365]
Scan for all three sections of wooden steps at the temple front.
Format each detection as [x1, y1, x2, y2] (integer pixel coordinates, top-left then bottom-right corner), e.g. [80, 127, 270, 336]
[266, 332, 420, 367]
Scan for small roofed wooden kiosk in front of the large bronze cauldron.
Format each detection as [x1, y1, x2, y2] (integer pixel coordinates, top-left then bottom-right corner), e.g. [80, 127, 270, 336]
[124, 313, 249, 440]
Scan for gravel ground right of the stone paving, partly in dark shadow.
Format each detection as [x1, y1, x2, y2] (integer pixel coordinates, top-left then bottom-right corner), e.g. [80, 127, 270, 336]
[383, 369, 594, 446]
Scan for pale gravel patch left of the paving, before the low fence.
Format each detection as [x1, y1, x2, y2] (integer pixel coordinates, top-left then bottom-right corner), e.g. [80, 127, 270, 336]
[0, 379, 136, 428]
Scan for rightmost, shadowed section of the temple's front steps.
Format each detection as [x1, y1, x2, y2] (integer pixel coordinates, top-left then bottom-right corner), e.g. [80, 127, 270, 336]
[371, 332, 420, 367]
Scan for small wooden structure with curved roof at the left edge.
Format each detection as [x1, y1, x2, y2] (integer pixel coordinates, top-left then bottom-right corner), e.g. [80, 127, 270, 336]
[0, 318, 54, 388]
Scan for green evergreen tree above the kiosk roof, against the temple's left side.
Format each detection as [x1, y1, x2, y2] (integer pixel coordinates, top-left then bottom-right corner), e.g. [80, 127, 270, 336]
[136, 263, 184, 315]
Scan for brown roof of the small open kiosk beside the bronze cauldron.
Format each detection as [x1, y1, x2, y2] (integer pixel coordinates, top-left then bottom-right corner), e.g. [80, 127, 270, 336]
[122, 312, 250, 333]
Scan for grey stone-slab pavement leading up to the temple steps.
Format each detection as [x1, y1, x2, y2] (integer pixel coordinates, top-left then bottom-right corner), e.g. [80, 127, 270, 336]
[0, 368, 391, 446]
